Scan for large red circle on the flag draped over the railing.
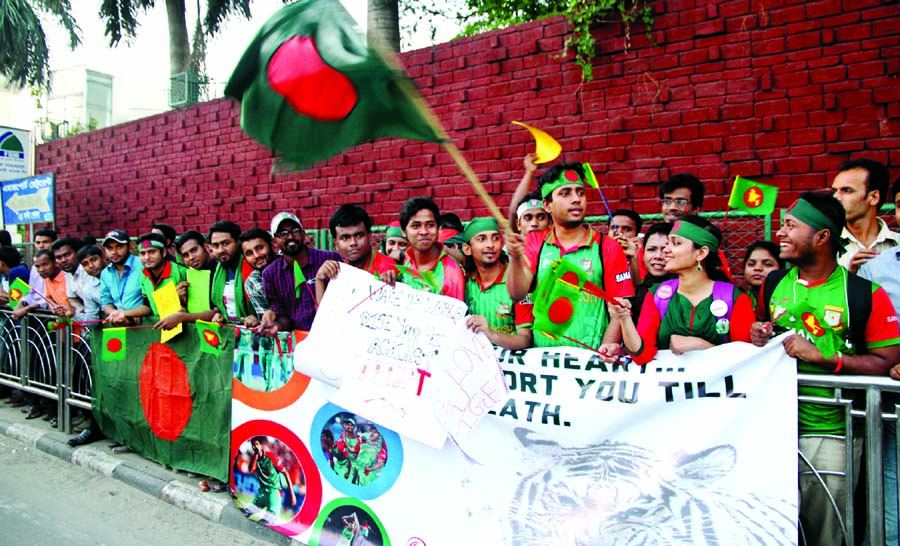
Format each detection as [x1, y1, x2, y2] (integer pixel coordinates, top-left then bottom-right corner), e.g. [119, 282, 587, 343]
[140, 343, 193, 441]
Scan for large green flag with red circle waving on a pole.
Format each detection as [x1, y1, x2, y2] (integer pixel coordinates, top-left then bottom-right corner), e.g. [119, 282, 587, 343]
[225, 0, 442, 167]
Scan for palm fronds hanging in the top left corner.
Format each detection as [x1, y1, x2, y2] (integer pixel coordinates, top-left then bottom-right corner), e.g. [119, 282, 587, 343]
[0, 0, 81, 87]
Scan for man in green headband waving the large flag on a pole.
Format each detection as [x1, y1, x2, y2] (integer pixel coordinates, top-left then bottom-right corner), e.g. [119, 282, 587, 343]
[506, 163, 634, 352]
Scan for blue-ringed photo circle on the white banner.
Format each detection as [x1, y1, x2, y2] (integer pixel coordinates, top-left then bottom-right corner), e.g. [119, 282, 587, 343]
[309, 403, 403, 499]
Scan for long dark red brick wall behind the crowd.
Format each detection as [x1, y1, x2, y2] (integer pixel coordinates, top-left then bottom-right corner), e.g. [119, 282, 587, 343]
[36, 0, 900, 234]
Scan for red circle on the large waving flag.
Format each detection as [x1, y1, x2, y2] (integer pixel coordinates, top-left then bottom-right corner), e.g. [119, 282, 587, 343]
[266, 36, 359, 121]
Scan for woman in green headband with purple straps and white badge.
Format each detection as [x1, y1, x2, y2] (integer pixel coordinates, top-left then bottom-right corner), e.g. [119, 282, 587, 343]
[609, 216, 755, 364]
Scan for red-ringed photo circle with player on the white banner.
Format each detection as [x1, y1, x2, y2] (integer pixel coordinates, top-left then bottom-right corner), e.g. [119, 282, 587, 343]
[230, 420, 322, 536]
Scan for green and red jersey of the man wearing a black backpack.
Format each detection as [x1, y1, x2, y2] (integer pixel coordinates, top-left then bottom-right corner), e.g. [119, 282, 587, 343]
[757, 266, 900, 435]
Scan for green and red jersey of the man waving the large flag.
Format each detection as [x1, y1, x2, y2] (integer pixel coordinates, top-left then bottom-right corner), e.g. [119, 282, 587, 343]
[525, 228, 634, 348]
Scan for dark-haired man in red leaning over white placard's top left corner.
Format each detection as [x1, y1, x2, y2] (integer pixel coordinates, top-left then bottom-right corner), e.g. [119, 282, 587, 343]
[316, 205, 398, 301]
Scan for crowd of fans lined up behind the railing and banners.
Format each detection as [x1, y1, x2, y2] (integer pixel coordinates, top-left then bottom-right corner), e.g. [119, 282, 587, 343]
[0, 156, 900, 544]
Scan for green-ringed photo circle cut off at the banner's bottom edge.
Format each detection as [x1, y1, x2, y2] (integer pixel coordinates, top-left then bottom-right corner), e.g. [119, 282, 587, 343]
[309, 498, 391, 546]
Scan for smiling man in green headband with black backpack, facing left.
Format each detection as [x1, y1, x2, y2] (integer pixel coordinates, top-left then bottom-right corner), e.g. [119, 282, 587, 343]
[751, 192, 900, 546]
